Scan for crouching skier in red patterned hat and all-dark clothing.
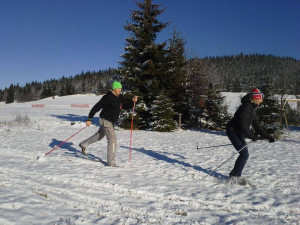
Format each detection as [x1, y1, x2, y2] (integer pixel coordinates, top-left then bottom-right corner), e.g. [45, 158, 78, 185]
[226, 88, 275, 177]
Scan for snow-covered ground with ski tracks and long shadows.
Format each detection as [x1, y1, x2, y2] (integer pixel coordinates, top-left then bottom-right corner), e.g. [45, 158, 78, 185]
[0, 95, 300, 225]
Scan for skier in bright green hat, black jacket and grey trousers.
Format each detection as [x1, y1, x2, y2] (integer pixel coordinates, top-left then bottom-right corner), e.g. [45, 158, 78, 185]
[79, 81, 137, 166]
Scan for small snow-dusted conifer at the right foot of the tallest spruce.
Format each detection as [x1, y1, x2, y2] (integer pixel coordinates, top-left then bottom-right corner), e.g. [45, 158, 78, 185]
[150, 92, 176, 132]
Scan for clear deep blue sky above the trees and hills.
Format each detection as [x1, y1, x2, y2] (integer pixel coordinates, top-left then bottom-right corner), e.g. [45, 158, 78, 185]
[0, 0, 300, 89]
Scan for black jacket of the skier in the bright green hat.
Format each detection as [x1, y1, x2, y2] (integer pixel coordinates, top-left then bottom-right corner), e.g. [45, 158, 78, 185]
[88, 91, 133, 123]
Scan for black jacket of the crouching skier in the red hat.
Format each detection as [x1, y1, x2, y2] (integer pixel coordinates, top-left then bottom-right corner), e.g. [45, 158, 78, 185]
[227, 94, 271, 139]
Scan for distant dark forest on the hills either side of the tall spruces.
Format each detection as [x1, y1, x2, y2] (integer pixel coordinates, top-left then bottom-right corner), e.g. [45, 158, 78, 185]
[0, 54, 300, 103]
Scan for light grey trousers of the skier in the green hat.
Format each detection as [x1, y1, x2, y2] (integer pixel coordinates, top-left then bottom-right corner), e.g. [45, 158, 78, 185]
[80, 118, 117, 166]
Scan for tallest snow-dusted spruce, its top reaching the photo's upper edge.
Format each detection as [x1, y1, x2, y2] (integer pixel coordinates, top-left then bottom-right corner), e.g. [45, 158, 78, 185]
[120, 0, 168, 127]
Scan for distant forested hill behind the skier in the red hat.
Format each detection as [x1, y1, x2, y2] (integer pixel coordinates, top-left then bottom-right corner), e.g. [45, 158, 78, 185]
[203, 53, 300, 95]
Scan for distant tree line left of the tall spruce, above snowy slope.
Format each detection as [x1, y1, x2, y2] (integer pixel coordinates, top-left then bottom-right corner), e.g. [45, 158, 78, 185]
[0, 69, 119, 104]
